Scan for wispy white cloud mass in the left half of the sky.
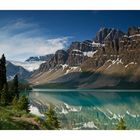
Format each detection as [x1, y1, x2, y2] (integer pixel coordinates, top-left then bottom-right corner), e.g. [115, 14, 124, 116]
[0, 20, 69, 60]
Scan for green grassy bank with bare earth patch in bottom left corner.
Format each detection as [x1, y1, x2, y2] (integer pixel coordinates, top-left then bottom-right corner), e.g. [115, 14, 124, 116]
[0, 106, 47, 130]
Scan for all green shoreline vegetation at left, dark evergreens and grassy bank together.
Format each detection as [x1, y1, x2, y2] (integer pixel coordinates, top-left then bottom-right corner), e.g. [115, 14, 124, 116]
[0, 54, 60, 130]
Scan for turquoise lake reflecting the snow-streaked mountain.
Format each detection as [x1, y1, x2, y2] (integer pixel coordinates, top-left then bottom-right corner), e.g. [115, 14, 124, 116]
[29, 89, 140, 130]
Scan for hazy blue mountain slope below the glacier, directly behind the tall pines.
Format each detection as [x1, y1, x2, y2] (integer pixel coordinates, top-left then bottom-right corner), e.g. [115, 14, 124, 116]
[6, 61, 32, 81]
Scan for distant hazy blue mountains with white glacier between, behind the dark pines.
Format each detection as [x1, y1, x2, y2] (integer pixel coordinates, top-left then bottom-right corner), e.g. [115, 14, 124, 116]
[7, 54, 54, 80]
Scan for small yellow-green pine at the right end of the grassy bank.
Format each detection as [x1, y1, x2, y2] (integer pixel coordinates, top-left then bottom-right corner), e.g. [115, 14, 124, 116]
[45, 106, 60, 129]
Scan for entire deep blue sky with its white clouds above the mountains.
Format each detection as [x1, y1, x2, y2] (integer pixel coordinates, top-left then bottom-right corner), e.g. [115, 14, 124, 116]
[0, 11, 140, 61]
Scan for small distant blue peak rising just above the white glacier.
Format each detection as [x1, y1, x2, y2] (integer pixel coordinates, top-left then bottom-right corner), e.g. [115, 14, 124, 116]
[25, 54, 54, 62]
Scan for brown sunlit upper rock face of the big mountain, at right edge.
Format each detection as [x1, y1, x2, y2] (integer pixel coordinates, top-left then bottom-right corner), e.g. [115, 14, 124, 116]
[82, 27, 140, 70]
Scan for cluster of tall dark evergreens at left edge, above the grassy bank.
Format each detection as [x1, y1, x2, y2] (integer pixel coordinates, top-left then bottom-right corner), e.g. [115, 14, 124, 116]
[0, 54, 29, 112]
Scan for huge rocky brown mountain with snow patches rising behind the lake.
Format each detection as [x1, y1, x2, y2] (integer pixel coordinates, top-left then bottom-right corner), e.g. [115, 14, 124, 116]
[29, 27, 140, 89]
